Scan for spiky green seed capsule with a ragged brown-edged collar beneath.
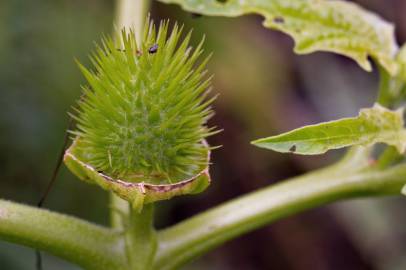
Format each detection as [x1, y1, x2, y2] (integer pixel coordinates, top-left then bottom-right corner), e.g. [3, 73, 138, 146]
[64, 21, 216, 209]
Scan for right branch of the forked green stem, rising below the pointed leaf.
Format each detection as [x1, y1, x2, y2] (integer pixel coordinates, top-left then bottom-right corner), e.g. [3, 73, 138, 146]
[155, 148, 406, 270]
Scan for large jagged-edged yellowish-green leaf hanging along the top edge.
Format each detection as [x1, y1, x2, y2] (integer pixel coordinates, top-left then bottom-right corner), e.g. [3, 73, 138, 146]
[160, 0, 398, 75]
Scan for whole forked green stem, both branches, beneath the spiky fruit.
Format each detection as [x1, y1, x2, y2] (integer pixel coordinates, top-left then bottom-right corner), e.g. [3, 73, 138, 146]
[0, 148, 406, 270]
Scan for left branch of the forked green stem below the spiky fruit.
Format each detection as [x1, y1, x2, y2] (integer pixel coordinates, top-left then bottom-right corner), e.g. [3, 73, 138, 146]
[0, 200, 127, 270]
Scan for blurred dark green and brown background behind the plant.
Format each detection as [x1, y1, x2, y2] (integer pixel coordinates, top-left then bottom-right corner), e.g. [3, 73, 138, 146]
[0, 0, 406, 270]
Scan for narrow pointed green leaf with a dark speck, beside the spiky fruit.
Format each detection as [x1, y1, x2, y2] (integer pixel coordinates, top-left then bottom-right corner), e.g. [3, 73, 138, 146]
[252, 104, 406, 155]
